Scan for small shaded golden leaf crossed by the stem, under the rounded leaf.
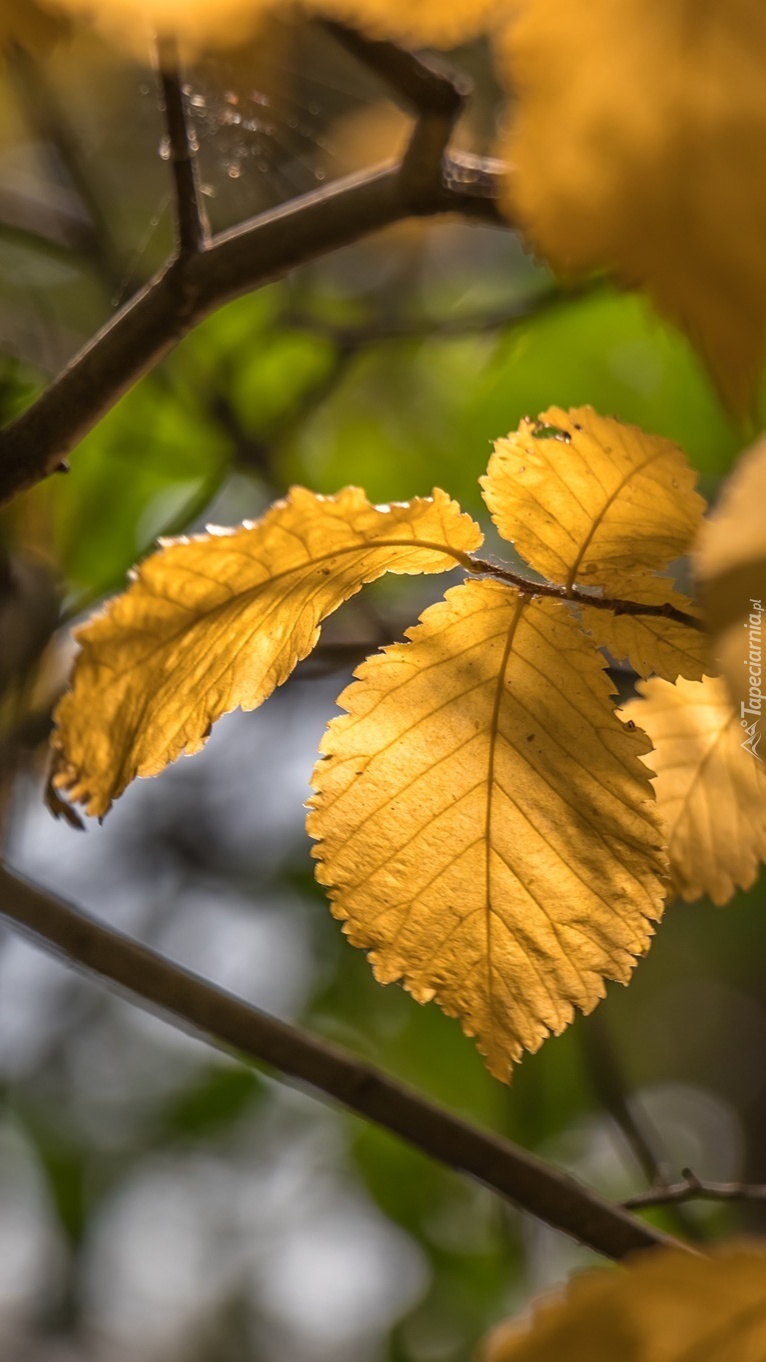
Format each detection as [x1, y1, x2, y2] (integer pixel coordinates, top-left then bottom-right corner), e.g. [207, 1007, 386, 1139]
[581, 577, 710, 681]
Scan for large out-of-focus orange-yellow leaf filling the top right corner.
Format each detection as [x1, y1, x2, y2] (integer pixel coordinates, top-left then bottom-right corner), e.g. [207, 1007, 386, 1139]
[497, 0, 766, 410]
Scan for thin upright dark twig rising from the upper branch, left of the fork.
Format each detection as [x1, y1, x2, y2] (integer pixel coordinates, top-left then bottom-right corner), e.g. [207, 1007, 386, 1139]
[157, 37, 210, 257]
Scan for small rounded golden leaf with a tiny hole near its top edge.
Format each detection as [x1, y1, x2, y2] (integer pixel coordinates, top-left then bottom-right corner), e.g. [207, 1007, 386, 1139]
[481, 407, 705, 597]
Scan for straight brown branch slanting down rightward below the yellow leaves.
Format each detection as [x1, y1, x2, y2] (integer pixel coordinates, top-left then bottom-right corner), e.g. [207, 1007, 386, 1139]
[0, 868, 694, 1258]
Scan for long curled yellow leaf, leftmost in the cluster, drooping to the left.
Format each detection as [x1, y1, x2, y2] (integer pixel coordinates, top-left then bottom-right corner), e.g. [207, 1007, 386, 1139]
[52, 488, 481, 814]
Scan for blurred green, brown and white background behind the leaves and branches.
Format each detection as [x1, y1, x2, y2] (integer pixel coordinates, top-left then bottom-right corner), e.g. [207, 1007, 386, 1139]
[0, 13, 766, 1362]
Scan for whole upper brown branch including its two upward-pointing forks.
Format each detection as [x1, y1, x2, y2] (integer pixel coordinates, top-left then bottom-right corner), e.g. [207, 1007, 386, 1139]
[0, 19, 508, 503]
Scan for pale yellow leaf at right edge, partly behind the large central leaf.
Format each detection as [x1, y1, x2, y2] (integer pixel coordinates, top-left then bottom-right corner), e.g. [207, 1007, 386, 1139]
[623, 677, 766, 904]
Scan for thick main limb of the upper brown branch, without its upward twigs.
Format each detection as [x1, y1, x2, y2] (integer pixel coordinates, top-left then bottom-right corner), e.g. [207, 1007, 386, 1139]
[0, 165, 500, 503]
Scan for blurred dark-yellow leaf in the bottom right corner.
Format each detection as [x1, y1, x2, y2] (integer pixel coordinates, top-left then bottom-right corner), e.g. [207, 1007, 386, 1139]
[478, 1239, 766, 1362]
